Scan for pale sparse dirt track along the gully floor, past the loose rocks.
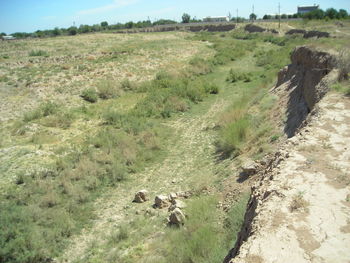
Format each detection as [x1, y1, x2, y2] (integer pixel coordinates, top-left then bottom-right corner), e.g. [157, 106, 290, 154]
[57, 97, 230, 262]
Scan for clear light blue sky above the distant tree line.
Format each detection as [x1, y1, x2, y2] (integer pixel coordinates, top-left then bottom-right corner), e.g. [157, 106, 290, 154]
[0, 0, 350, 34]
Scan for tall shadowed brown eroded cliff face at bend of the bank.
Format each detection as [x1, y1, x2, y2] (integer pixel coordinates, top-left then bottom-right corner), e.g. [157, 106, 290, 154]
[274, 46, 336, 137]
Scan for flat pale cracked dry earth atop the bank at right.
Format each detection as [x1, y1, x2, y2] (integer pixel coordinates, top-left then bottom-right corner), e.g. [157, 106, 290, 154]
[231, 93, 350, 263]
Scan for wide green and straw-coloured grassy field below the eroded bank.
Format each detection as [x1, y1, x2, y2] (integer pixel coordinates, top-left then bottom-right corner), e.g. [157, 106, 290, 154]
[0, 20, 347, 263]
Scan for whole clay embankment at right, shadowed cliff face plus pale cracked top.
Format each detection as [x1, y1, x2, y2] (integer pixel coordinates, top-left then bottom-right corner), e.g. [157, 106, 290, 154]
[224, 47, 350, 263]
